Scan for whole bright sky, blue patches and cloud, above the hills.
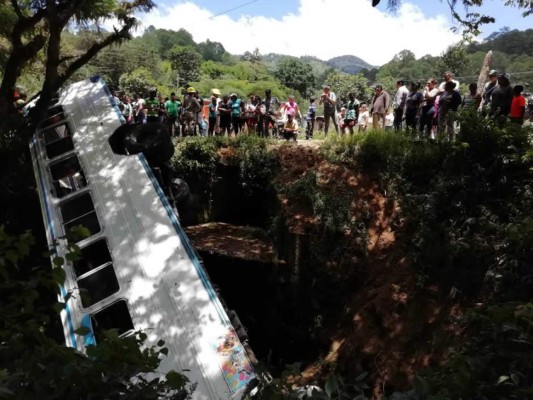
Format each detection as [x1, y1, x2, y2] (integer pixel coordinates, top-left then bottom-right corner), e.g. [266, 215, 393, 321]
[130, 0, 533, 66]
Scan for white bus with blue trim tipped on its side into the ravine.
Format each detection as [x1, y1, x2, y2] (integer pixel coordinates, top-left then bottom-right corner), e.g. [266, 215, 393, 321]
[30, 78, 255, 400]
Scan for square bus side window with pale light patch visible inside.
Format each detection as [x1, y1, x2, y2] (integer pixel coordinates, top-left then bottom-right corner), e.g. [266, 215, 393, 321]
[50, 155, 87, 198]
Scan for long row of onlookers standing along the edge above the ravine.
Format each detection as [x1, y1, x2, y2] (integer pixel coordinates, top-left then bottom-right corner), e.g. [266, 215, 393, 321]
[114, 70, 533, 140]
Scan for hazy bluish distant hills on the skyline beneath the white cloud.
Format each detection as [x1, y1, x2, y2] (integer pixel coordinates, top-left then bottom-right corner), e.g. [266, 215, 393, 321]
[262, 53, 375, 76]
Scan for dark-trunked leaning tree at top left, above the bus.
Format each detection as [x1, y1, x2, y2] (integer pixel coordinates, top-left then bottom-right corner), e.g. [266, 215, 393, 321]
[0, 0, 154, 125]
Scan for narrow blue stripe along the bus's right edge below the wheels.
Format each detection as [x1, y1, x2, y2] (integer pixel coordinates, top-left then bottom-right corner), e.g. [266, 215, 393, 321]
[138, 153, 231, 326]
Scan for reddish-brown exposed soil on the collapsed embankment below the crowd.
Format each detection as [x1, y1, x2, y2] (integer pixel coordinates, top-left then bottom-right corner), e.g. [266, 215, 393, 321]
[188, 142, 461, 399]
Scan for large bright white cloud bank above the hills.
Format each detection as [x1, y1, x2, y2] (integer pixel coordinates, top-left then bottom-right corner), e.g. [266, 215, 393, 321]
[131, 0, 460, 65]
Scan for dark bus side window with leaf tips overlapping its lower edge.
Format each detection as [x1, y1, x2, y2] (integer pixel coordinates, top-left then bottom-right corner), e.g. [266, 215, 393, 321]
[59, 193, 100, 236]
